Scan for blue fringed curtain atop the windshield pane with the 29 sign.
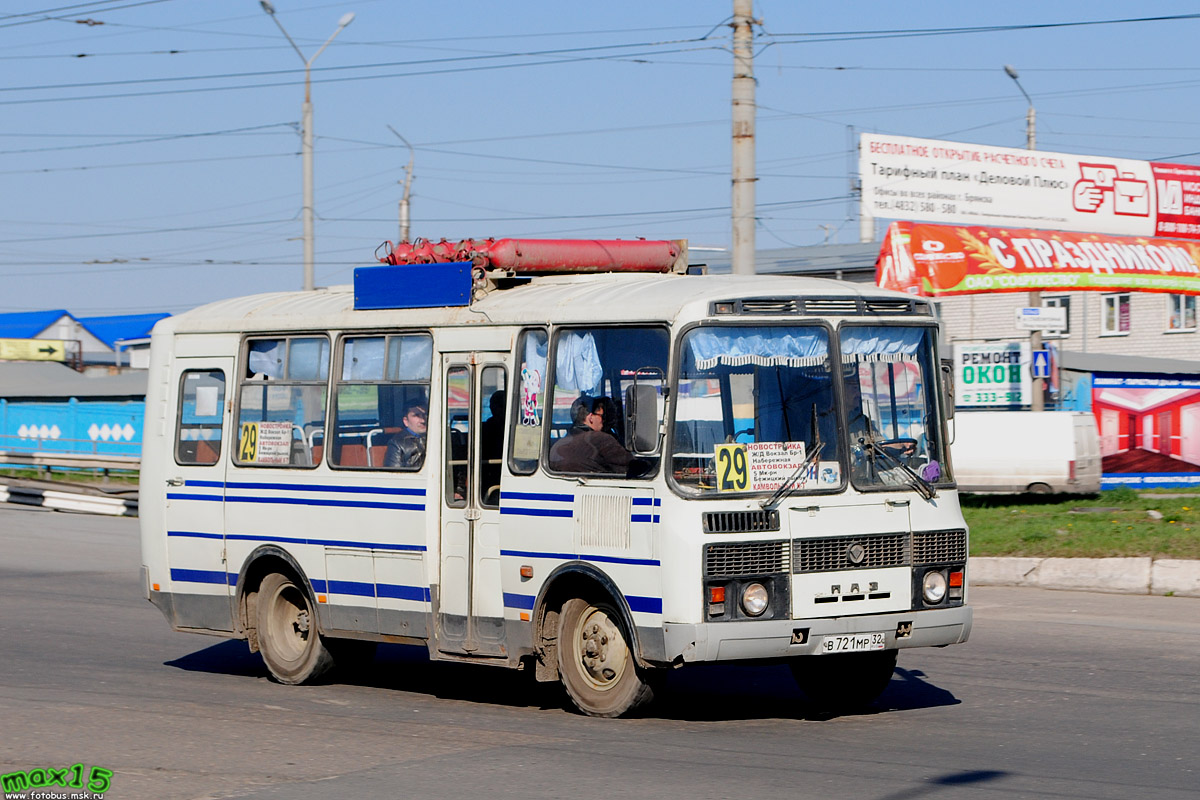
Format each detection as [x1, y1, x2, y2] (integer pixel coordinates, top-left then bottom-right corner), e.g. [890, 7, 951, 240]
[685, 327, 829, 372]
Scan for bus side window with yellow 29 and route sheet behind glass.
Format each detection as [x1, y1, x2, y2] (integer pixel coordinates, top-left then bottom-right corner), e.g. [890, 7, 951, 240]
[234, 336, 329, 467]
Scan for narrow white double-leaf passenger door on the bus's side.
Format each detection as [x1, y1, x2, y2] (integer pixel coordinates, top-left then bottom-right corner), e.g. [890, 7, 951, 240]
[437, 353, 508, 657]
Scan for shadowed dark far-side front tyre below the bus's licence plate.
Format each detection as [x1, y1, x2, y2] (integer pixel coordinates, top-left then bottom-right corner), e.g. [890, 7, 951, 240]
[788, 650, 896, 712]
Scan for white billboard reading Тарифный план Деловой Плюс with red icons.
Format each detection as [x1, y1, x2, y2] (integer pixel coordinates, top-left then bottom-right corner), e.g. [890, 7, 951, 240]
[859, 133, 1200, 239]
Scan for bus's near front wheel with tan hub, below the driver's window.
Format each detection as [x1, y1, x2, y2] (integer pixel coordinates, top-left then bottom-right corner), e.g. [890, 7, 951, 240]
[557, 599, 654, 717]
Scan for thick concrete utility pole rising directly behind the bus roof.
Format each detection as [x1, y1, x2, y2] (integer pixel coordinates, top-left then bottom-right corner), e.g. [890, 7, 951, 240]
[731, 0, 757, 275]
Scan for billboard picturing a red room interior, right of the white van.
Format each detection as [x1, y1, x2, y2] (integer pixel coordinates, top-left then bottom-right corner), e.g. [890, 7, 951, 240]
[1092, 374, 1200, 489]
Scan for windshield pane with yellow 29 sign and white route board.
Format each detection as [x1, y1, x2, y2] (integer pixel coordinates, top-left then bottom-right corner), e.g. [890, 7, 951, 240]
[671, 325, 844, 495]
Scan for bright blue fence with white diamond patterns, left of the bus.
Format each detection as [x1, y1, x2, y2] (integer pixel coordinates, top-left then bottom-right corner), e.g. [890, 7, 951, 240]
[0, 398, 145, 456]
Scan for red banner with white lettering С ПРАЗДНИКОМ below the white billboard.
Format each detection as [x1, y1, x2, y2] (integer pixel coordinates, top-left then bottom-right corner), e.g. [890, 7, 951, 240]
[875, 222, 1200, 297]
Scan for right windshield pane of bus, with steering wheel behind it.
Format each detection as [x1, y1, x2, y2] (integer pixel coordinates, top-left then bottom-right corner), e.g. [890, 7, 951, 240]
[839, 325, 949, 493]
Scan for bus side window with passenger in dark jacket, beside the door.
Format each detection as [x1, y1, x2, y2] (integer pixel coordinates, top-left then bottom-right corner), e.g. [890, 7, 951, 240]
[329, 333, 433, 470]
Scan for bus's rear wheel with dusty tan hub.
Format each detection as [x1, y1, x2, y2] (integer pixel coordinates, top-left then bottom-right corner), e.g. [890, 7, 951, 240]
[257, 572, 334, 684]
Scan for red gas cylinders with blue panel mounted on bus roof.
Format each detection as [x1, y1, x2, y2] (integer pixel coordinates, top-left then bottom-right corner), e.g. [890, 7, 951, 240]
[354, 239, 688, 309]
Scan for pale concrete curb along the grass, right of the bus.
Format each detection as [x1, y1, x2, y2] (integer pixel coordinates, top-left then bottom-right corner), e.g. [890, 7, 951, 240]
[968, 557, 1200, 597]
